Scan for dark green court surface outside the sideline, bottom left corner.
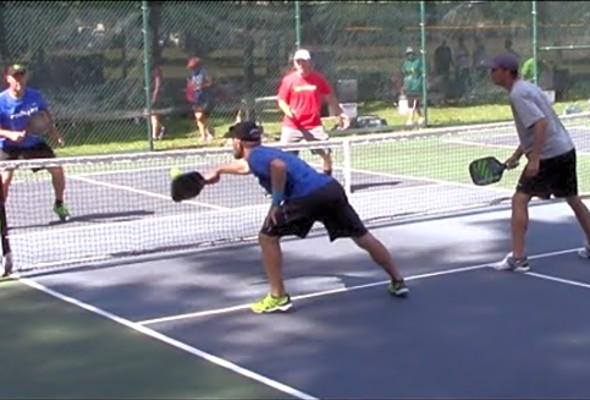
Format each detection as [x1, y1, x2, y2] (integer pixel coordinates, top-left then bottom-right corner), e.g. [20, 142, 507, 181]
[0, 281, 294, 399]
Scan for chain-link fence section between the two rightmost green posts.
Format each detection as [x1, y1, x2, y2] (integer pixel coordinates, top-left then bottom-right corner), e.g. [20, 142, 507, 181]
[425, 1, 532, 106]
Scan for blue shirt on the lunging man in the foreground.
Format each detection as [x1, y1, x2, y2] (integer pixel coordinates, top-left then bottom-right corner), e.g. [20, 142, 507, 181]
[248, 146, 334, 200]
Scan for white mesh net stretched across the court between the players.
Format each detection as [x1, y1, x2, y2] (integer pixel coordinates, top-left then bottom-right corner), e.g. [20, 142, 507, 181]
[0, 114, 590, 271]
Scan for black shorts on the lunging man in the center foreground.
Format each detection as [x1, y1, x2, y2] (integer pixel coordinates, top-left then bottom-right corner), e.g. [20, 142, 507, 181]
[260, 181, 367, 241]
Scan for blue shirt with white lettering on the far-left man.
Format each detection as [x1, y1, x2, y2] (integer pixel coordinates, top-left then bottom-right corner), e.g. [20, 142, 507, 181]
[0, 88, 47, 149]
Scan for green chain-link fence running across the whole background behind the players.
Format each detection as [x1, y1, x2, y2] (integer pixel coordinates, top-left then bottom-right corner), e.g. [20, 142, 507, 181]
[0, 1, 590, 155]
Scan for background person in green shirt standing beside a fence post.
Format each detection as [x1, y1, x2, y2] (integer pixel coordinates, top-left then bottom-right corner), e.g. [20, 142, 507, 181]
[401, 47, 424, 125]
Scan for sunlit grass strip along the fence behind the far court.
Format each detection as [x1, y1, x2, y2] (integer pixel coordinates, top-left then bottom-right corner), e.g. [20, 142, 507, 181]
[56, 98, 585, 157]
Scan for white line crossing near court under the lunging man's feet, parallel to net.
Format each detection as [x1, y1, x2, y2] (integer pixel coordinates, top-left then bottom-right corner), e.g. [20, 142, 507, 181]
[136, 247, 579, 326]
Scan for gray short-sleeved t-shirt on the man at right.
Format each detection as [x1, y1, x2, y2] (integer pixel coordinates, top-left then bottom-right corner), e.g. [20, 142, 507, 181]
[509, 79, 574, 160]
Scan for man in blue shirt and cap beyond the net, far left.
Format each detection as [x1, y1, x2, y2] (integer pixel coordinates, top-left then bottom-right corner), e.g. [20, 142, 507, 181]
[0, 64, 70, 222]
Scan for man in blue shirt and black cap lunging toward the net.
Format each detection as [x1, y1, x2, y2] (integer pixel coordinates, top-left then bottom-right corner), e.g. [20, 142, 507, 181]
[204, 122, 409, 313]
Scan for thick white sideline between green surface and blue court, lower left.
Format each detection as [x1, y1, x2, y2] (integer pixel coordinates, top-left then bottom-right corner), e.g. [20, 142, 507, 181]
[19, 278, 319, 400]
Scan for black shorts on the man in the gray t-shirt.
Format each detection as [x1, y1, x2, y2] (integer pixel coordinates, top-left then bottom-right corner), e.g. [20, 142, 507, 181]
[516, 149, 578, 199]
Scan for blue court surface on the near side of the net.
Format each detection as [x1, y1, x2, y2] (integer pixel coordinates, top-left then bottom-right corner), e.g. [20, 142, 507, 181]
[17, 203, 590, 399]
